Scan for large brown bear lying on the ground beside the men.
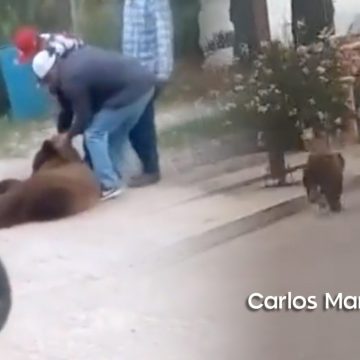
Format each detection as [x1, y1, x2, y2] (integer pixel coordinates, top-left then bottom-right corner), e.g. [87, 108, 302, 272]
[0, 140, 100, 229]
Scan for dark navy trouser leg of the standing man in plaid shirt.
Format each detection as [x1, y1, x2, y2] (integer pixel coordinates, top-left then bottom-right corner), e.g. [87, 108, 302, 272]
[129, 91, 160, 187]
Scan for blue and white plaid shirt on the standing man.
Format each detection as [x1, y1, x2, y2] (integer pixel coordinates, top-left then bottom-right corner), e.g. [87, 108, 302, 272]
[122, 0, 174, 81]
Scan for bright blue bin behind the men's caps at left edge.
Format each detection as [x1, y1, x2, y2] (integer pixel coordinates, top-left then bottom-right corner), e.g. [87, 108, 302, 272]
[0, 46, 51, 121]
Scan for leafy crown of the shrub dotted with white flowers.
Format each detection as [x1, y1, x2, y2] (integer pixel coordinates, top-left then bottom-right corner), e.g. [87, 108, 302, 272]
[238, 34, 346, 146]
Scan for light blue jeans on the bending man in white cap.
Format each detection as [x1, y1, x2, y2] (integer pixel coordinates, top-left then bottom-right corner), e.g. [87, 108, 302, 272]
[84, 89, 154, 190]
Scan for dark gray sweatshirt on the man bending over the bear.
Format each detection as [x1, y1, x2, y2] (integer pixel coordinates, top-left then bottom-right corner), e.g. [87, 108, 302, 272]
[54, 46, 156, 136]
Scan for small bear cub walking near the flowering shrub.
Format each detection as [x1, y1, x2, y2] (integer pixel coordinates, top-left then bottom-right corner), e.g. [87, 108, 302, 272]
[303, 153, 345, 212]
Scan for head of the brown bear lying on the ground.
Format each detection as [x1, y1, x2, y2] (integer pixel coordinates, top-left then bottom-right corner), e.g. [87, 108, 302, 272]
[32, 140, 82, 173]
